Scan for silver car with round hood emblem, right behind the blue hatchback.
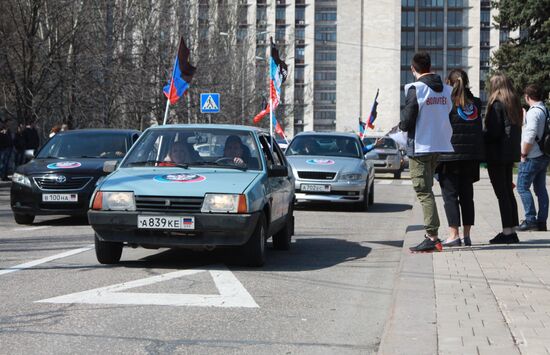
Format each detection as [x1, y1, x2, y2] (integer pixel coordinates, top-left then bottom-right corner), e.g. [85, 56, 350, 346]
[285, 132, 374, 211]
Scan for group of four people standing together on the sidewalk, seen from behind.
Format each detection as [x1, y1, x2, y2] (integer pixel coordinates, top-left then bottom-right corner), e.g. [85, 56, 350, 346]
[399, 52, 550, 252]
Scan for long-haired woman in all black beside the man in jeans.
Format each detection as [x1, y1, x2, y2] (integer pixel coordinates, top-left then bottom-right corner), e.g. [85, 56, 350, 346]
[483, 73, 523, 244]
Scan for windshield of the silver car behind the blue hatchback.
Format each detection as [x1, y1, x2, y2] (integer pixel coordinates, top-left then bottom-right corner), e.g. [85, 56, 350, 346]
[286, 135, 363, 158]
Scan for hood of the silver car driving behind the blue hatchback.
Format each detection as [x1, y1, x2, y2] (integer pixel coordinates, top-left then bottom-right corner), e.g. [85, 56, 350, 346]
[286, 155, 365, 173]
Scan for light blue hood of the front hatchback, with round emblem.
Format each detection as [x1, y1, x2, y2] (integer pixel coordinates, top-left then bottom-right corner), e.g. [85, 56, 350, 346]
[100, 167, 259, 197]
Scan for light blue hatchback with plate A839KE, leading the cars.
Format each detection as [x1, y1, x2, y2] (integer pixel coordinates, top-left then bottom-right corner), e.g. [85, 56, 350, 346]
[88, 125, 294, 266]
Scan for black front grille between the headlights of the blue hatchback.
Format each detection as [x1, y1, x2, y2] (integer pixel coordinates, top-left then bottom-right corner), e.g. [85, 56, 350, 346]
[136, 196, 204, 212]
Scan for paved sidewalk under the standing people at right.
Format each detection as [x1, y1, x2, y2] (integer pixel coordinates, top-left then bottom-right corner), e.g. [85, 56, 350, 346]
[379, 170, 550, 355]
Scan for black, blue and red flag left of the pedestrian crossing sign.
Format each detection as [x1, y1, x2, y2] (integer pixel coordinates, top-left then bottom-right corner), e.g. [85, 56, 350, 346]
[163, 37, 197, 105]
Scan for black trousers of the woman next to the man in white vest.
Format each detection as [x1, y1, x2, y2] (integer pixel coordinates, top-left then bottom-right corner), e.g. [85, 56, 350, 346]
[438, 161, 479, 227]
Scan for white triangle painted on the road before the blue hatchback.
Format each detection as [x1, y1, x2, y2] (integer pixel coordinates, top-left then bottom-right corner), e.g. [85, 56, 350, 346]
[35, 265, 259, 308]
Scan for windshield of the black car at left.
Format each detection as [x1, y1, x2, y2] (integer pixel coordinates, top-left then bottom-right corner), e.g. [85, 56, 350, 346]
[36, 132, 129, 159]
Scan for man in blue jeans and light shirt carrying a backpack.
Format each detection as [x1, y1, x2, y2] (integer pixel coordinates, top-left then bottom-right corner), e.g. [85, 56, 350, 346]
[517, 84, 550, 231]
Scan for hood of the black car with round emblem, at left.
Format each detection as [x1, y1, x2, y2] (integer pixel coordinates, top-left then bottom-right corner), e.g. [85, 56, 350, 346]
[17, 158, 116, 176]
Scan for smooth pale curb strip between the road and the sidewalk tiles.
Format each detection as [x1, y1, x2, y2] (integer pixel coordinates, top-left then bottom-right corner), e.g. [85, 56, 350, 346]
[378, 196, 438, 354]
